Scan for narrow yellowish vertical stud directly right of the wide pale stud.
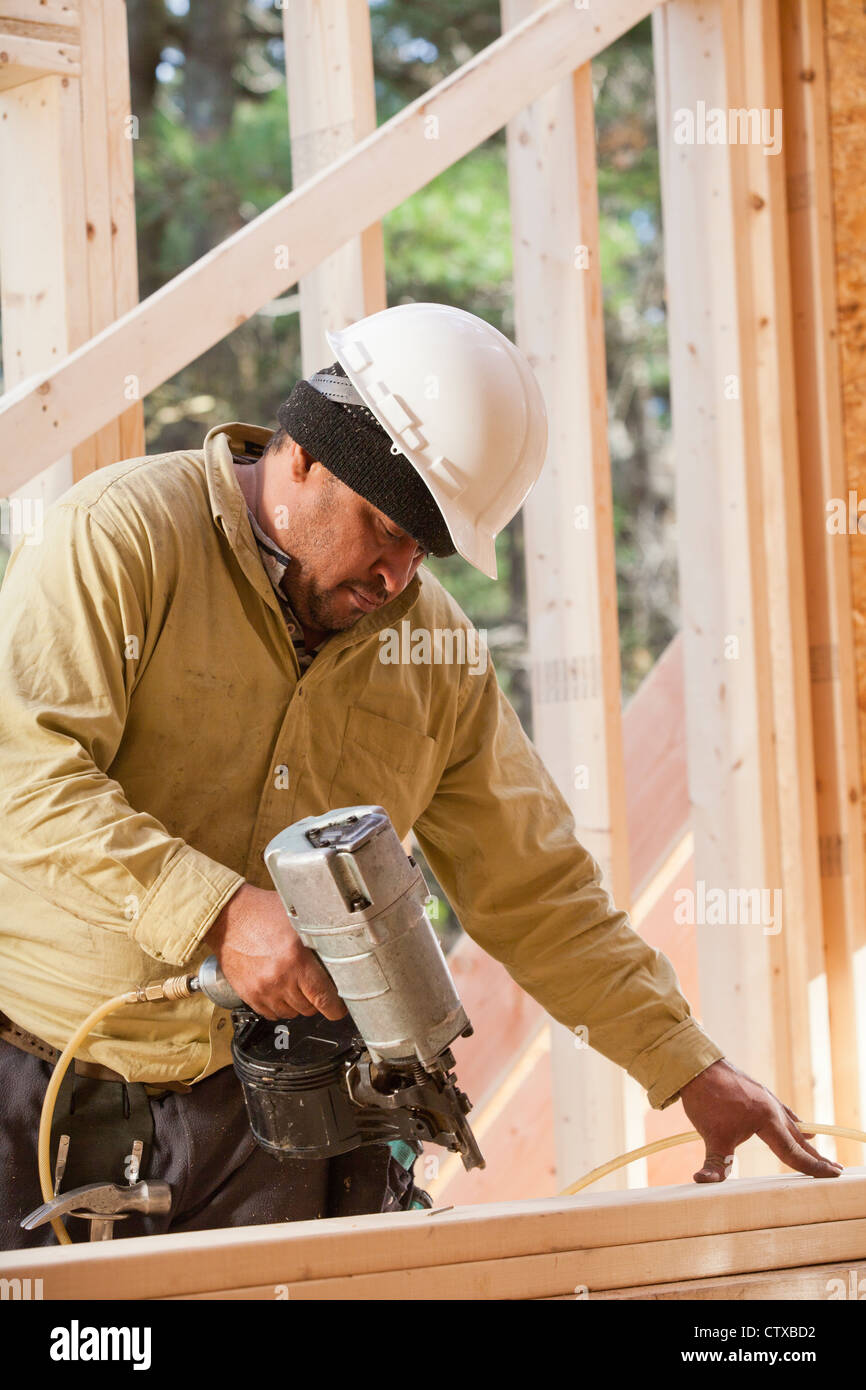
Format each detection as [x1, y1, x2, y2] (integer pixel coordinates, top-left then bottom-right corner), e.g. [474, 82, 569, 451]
[726, 0, 830, 1115]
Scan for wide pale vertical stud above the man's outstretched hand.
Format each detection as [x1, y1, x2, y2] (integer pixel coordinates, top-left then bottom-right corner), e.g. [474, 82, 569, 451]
[653, 0, 777, 1156]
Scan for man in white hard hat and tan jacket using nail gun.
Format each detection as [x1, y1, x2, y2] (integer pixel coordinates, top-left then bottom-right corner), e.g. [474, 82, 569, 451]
[0, 304, 841, 1245]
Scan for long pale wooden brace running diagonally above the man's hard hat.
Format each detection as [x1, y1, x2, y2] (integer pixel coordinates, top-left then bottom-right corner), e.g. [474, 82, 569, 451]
[0, 0, 653, 492]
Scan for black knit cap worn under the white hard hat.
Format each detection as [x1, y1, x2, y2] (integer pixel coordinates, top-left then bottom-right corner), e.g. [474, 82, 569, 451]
[277, 361, 456, 555]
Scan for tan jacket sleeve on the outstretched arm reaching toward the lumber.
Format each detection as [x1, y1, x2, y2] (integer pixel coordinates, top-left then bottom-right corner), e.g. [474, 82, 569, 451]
[414, 650, 723, 1109]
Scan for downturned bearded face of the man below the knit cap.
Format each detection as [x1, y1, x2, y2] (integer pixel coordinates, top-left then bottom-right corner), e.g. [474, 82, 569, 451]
[261, 441, 425, 632]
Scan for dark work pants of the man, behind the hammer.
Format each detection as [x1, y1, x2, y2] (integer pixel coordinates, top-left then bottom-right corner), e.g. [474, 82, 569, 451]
[0, 1038, 413, 1250]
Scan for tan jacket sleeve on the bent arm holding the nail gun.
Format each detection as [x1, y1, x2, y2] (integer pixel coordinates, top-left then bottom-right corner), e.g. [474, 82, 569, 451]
[0, 502, 243, 965]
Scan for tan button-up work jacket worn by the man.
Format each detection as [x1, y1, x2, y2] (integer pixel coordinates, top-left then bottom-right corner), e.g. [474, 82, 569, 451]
[0, 424, 723, 1108]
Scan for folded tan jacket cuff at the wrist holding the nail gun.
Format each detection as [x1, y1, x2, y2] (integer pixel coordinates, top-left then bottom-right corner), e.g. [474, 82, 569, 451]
[132, 845, 246, 965]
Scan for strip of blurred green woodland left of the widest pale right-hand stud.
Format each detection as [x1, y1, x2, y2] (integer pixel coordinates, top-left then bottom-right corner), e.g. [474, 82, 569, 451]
[592, 19, 680, 692]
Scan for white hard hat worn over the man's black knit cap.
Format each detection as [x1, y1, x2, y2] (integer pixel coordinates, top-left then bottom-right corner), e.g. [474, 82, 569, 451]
[325, 304, 548, 580]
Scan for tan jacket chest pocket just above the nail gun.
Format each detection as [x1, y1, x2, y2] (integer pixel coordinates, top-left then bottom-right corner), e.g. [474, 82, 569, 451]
[328, 705, 438, 835]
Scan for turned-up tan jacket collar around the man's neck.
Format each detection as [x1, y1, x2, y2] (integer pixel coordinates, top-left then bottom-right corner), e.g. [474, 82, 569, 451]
[203, 421, 421, 667]
